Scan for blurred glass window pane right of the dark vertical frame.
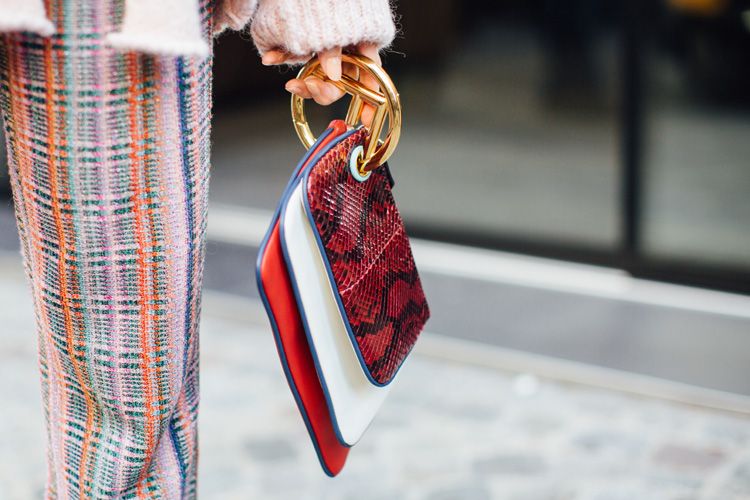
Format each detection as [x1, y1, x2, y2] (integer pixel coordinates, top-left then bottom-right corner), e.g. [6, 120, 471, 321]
[644, 0, 750, 268]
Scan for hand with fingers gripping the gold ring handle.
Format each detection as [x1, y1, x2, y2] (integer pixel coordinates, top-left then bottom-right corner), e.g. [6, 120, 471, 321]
[262, 43, 382, 127]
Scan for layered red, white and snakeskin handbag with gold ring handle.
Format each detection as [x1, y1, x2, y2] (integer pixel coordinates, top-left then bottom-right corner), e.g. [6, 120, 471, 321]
[256, 55, 430, 476]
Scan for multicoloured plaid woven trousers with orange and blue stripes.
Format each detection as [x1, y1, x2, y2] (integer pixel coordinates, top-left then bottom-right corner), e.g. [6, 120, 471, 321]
[0, 0, 212, 500]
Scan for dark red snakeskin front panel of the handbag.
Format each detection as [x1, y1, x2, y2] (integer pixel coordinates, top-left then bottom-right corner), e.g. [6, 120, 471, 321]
[307, 130, 430, 385]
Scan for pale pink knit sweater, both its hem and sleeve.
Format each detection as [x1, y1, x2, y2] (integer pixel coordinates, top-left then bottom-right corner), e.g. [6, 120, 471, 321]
[0, 0, 396, 62]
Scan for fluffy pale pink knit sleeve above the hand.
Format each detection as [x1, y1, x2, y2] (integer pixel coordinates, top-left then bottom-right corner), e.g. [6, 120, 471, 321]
[217, 0, 396, 63]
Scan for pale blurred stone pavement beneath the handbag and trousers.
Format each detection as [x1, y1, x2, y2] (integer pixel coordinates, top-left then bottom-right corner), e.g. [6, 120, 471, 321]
[0, 254, 750, 500]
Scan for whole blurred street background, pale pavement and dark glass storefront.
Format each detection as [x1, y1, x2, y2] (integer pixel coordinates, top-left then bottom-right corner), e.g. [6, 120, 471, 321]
[0, 0, 750, 500]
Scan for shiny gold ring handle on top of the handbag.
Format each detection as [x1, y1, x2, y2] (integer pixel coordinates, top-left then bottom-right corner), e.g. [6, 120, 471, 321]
[292, 54, 401, 172]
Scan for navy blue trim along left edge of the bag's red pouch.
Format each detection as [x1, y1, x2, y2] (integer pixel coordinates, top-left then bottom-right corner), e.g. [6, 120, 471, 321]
[255, 128, 358, 477]
